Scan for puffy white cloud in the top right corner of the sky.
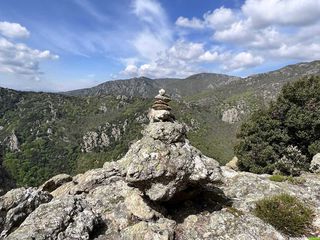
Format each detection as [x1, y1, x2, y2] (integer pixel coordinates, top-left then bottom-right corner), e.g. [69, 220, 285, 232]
[242, 0, 320, 26]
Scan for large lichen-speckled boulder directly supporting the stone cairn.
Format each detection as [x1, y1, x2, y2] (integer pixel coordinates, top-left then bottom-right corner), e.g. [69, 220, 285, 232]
[124, 122, 221, 201]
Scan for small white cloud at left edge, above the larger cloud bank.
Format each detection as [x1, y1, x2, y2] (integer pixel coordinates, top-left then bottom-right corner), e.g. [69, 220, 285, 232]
[0, 22, 30, 38]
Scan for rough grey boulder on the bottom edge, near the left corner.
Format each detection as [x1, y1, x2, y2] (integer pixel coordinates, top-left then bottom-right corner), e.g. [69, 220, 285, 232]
[6, 196, 100, 240]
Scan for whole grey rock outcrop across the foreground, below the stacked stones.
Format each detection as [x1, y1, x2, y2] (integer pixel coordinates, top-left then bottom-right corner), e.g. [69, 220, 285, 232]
[0, 93, 320, 240]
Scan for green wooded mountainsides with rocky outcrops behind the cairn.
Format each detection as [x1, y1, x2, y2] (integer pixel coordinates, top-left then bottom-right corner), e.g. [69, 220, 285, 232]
[0, 61, 320, 191]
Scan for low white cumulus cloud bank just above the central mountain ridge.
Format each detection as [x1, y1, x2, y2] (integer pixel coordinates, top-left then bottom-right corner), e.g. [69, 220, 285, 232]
[122, 40, 264, 78]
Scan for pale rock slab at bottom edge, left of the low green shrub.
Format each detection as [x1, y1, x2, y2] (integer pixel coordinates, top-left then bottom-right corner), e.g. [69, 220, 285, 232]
[175, 209, 286, 240]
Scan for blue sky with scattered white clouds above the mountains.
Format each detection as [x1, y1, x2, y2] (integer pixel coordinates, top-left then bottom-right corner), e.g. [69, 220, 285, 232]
[0, 0, 320, 92]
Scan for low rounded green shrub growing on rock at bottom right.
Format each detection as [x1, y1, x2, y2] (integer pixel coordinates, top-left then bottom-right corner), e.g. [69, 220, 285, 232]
[254, 194, 314, 237]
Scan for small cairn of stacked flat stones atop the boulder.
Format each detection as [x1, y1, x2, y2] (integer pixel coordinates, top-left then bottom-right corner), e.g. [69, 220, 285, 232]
[148, 89, 175, 122]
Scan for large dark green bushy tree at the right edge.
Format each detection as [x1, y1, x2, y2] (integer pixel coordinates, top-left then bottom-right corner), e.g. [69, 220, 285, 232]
[235, 76, 320, 176]
